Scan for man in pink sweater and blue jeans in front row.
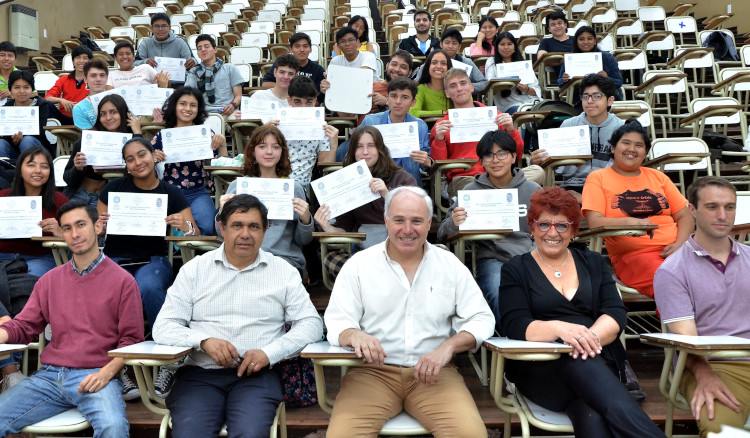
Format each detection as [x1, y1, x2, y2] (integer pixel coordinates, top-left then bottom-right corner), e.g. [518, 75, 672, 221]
[0, 201, 143, 437]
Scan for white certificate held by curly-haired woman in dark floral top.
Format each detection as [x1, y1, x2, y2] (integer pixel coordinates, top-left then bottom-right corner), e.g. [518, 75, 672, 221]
[161, 125, 214, 163]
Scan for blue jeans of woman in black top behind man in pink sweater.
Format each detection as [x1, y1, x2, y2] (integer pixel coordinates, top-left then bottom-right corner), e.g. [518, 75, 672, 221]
[112, 256, 172, 328]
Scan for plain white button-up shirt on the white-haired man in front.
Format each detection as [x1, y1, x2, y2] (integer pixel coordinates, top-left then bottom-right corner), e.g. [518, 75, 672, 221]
[325, 240, 495, 366]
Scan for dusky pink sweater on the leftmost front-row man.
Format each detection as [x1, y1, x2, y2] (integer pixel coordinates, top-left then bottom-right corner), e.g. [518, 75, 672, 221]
[0, 258, 143, 368]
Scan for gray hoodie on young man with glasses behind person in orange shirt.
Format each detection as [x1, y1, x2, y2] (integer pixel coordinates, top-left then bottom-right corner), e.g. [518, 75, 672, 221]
[557, 113, 625, 192]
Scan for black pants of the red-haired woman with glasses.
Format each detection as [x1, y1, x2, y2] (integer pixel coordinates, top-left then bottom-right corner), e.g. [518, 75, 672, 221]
[507, 355, 664, 438]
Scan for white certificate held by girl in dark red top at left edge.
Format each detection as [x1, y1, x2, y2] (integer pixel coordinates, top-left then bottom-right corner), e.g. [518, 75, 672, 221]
[0, 196, 42, 239]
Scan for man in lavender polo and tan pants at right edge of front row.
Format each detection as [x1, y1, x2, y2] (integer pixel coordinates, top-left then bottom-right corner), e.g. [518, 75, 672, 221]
[654, 176, 750, 437]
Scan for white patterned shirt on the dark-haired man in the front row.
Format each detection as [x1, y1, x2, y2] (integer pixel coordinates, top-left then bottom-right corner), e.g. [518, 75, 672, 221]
[153, 245, 323, 368]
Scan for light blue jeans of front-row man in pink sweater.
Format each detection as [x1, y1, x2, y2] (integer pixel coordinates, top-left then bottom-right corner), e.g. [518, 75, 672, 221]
[0, 365, 130, 438]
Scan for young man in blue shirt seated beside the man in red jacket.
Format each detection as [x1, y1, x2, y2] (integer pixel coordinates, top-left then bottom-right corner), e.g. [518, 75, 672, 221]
[360, 78, 432, 187]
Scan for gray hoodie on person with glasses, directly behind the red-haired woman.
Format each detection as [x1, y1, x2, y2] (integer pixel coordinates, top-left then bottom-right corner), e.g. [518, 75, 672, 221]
[437, 169, 541, 263]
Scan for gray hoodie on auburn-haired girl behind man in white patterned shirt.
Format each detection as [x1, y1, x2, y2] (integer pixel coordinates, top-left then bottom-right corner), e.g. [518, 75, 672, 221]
[216, 180, 315, 271]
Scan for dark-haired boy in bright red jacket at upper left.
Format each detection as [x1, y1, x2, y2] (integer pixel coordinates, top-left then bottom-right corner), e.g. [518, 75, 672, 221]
[44, 45, 94, 125]
